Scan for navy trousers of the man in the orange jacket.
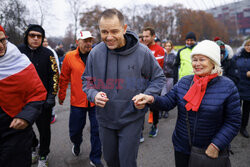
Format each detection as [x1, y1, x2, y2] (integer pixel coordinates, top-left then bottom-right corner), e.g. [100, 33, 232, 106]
[69, 106, 102, 163]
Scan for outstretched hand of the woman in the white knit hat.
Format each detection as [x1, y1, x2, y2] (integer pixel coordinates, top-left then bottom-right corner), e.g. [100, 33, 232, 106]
[132, 93, 154, 109]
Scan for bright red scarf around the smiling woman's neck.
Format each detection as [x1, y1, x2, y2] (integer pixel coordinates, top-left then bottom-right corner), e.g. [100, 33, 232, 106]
[183, 74, 218, 112]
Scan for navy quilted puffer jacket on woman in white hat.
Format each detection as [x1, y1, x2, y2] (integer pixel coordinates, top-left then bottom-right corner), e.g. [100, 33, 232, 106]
[152, 75, 241, 154]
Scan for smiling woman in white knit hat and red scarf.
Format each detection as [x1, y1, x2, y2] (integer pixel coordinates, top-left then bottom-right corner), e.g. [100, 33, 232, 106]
[132, 40, 241, 167]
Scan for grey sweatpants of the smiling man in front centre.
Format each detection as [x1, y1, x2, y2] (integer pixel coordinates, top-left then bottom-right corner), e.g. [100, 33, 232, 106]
[100, 118, 144, 167]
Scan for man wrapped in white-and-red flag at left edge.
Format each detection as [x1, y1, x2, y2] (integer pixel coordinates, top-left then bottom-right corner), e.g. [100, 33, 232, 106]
[0, 26, 47, 167]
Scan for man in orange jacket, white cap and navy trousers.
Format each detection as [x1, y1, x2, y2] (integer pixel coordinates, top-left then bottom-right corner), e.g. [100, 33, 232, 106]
[58, 31, 103, 167]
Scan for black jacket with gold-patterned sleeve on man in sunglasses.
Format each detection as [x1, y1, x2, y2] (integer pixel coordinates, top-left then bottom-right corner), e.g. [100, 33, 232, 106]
[18, 44, 59, 105]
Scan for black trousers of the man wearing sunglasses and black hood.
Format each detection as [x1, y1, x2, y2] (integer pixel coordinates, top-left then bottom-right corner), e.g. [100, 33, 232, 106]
[32, 105, 52, 156]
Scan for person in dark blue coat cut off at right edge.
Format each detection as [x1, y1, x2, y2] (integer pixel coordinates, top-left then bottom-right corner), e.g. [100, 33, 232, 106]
[233, 39, 250, 138]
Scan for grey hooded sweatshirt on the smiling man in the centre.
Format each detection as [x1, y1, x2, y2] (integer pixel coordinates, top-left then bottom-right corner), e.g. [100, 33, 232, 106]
[82, 31, 165, 129]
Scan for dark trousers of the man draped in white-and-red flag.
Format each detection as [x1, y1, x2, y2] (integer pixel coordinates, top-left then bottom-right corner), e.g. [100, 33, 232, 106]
[0, 108, 32, 167]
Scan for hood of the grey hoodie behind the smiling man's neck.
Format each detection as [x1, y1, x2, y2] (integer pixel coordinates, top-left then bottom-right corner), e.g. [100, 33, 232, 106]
[109, 30, 139, 56]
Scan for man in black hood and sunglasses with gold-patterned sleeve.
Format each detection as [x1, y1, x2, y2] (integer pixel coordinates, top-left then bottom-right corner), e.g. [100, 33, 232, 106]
[18, 24, 59, 167]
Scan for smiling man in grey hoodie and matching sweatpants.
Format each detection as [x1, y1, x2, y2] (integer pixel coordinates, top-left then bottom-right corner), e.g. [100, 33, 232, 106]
[82, 9, 165, 167]
